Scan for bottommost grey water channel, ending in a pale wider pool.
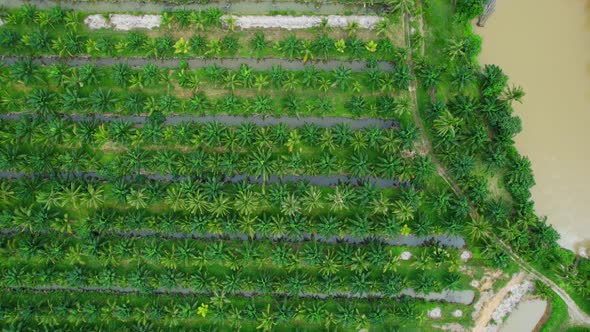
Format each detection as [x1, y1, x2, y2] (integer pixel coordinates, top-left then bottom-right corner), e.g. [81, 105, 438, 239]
[5, 285, 475, 305]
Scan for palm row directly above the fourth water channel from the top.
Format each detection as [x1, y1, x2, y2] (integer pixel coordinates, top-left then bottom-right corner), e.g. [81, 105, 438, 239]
[0, 145, 426, 183]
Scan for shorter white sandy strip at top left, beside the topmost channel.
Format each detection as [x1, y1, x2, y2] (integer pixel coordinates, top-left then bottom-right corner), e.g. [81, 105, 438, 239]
[84, 14, 162, 31]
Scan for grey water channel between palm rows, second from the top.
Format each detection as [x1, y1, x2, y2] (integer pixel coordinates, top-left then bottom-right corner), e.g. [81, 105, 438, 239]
[0, 56, 393, 72]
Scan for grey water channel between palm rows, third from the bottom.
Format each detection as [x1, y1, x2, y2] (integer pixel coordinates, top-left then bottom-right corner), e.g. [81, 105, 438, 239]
[0, 171, 410, 189]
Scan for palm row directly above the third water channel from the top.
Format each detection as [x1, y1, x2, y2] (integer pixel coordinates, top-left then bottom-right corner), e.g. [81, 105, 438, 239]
[5, 88, 408, 119]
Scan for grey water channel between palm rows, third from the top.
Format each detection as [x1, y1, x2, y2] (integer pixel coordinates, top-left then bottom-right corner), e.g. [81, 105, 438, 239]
[0, 113, 399, 129]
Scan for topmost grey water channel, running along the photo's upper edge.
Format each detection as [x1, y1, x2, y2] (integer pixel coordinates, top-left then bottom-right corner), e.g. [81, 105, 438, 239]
[2, 0, 378, 15]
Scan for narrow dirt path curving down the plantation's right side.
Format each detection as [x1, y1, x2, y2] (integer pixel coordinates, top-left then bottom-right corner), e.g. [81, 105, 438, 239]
[404, 1, 590, 331]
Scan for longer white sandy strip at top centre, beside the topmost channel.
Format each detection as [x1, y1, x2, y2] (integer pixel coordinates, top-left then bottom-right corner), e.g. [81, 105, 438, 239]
[222, 15, 382, 30]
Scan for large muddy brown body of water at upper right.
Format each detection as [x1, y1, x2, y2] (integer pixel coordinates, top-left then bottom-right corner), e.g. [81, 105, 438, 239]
[476, 0, 590, 254]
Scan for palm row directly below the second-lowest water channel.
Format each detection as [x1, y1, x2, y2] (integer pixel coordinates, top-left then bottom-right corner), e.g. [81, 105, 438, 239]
[2, 233, 460, 274]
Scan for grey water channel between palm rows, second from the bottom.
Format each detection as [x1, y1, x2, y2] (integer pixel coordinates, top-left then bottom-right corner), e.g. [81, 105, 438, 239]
[0, 228, 465, 249]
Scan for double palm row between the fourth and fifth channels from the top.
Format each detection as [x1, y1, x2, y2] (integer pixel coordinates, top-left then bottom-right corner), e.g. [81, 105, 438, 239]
[0, 179, 469, 239]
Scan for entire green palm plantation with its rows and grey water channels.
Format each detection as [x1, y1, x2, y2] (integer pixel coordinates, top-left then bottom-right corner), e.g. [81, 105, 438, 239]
[0, 0, 585, 331]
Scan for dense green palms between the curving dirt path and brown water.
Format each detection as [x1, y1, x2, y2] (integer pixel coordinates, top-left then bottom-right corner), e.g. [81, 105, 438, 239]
[414, 0, 590, 312]
